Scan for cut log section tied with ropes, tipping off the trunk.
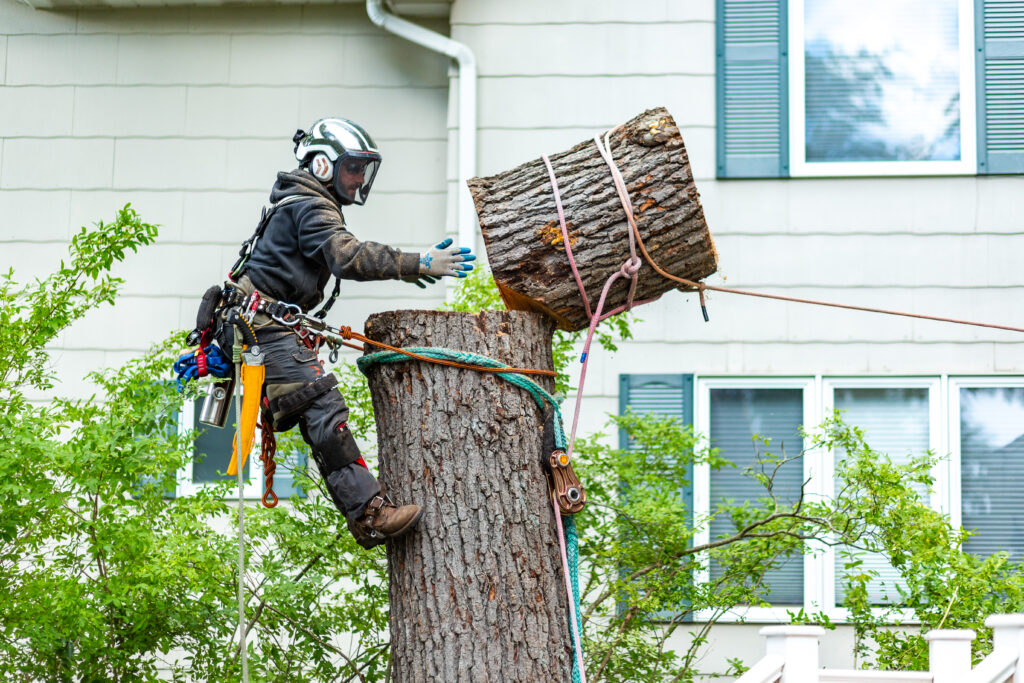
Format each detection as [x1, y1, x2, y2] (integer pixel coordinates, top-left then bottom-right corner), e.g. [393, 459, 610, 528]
[469, 108, 718, 330]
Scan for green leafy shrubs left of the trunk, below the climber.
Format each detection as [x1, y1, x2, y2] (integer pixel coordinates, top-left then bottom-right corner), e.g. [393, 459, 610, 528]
[0, 207, 388, 681]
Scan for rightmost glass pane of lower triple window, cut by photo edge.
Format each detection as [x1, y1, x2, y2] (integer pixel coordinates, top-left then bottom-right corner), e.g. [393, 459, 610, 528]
[959, 387, 1024, 562]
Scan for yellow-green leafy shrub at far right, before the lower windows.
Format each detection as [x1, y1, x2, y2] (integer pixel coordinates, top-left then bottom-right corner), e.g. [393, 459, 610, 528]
[814, 417, 1024, 671]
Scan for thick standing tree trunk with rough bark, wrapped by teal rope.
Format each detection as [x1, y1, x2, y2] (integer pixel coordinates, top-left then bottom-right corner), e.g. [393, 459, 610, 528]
[366, 310, 571, 683]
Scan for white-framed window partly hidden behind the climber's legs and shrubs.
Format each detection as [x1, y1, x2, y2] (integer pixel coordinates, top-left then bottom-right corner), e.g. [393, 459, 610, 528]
[177, 398, 308, 501]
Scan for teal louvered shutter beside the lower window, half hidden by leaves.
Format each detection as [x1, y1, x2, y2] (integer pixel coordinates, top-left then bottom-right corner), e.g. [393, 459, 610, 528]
[618, 375, 693, 622]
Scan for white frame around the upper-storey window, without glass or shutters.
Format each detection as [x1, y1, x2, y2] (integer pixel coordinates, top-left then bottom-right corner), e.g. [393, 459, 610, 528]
[783, 0, 980, 178]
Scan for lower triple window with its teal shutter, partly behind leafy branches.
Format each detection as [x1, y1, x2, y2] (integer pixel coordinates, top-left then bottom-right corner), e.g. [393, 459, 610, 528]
[620, 375, 1024, 621]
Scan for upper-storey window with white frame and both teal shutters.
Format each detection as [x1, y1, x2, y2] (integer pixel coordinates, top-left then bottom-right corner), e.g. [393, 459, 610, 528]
[716, 0, 1024, 177]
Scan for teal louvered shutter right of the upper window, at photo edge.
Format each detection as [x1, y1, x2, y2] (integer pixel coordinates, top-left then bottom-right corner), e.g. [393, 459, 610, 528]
[975, 0, 1024, 173]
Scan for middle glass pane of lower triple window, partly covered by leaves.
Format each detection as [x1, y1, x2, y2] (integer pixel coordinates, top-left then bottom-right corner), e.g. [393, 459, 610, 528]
[835, 387, 930, 605]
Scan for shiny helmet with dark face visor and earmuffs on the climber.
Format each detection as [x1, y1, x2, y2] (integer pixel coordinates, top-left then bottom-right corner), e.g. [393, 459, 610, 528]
[292, 118, 381, 205]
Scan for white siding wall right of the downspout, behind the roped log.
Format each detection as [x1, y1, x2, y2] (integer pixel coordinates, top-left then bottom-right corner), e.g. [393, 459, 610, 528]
[452, 0, 1024, 671]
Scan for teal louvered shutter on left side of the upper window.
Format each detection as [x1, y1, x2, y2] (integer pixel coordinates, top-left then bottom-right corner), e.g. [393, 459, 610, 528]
[715, 0, 790, 178]
